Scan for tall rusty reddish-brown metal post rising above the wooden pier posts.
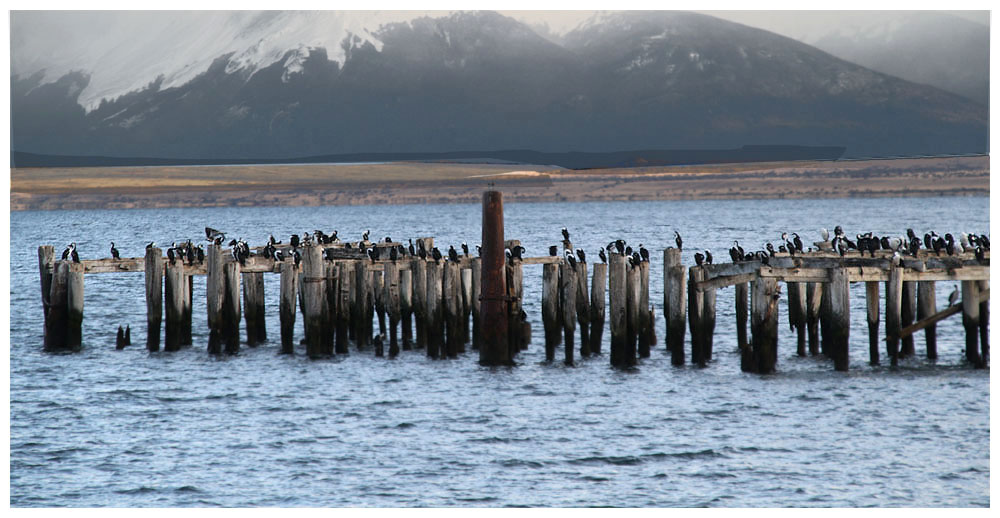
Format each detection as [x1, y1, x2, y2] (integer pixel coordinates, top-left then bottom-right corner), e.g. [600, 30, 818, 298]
[479, 191, 510, 365]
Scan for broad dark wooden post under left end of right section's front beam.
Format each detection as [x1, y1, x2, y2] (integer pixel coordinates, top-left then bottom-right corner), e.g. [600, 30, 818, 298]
[748, 278, 779, 374]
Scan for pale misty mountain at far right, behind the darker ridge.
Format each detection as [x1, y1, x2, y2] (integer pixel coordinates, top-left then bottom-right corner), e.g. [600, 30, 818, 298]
[810, 12, 990, 105]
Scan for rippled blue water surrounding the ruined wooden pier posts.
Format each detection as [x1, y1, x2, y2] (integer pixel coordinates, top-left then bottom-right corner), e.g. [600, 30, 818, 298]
[10, 198, 990, 507]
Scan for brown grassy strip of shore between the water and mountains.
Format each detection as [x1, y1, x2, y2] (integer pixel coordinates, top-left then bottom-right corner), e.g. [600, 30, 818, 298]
[10, 157, 990, 210]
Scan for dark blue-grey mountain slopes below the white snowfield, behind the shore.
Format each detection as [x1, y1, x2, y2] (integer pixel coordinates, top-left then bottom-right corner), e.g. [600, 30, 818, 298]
[11, 12, 987, 159]
